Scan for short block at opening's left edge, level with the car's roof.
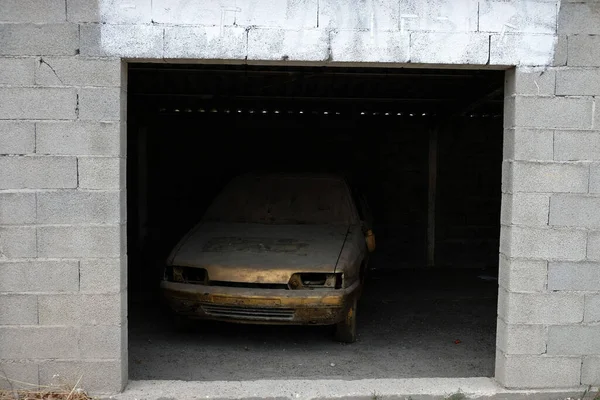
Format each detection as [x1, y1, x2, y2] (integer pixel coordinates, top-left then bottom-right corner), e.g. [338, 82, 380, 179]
[79, 157, 126, 190]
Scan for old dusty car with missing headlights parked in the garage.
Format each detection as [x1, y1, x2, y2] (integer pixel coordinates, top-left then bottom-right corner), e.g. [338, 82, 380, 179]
[161, 173, 375, 343]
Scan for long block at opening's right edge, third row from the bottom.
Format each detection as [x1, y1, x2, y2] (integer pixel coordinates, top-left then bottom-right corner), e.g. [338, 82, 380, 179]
[500, 288, 584, 325]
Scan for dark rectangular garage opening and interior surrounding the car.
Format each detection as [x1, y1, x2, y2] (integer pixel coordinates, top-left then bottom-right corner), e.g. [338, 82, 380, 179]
[127, 64, 504, 380]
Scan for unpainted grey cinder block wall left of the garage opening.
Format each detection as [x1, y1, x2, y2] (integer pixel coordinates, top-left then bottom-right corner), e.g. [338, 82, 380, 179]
[0, 0, 127, 392]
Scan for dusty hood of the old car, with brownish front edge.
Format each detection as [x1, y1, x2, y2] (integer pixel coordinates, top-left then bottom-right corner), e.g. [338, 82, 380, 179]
[169, 222, 348, 284]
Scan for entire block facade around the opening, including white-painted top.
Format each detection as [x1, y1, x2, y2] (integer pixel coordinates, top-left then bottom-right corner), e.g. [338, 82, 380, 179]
[0, 0, 600, 392]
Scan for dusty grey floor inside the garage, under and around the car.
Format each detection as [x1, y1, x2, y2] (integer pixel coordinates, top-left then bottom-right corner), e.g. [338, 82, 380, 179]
[129, 264, 497, 381]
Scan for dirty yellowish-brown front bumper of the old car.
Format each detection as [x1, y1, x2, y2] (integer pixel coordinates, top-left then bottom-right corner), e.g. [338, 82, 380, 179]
[161, 281, 359, 325]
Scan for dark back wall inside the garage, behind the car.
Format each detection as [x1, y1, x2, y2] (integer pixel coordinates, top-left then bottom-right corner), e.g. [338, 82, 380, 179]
[128, 109, 502, 282]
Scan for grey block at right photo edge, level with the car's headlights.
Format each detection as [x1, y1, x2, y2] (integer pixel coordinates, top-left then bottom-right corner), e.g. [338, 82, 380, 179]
[548, 262, 600, 291]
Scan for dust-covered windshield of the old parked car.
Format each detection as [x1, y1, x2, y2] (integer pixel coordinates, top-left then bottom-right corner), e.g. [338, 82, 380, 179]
[204, 175, 353, 224]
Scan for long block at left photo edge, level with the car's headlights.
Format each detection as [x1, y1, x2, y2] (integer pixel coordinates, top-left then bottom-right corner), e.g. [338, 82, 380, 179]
[0, 260, 79, 292]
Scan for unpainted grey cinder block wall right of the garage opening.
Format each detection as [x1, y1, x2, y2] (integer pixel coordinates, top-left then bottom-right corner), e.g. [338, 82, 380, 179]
[496, 1, 600, 388]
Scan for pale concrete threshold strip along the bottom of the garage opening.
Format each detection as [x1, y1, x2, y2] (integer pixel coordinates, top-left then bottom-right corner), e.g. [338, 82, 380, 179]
[116, 378, 584, 400]
